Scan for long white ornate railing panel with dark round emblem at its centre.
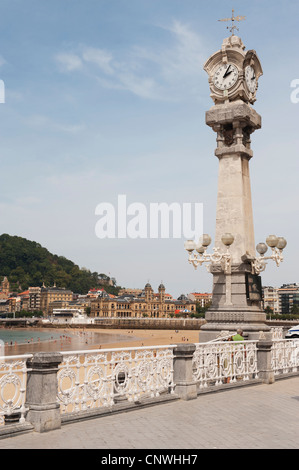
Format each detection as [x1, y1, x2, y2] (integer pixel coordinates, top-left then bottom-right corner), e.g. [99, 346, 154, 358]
[57, 345, 175, 413]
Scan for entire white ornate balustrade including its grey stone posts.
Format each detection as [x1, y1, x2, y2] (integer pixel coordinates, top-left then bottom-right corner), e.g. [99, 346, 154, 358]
[0, 331, 299, 432]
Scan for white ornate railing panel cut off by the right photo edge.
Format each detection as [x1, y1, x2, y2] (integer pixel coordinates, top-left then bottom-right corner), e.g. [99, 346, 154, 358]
[271, 339, 299, 375]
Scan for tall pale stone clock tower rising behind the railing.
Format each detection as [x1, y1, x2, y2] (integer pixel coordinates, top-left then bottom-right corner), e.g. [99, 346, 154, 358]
[200, 34, 269, 341]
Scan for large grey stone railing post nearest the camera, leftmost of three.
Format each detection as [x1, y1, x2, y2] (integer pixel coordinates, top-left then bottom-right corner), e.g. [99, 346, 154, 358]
[25, 352, 62, 432]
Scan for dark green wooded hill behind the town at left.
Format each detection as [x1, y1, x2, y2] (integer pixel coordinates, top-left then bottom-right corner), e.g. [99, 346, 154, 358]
[0, 234, 119, 294]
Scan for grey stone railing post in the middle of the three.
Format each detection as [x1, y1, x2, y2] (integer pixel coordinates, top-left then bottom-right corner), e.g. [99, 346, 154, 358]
[173, 343, 197, 400]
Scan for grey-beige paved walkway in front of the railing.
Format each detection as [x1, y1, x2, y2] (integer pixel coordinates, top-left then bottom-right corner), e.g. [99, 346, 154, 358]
[0, 377, 299, 449]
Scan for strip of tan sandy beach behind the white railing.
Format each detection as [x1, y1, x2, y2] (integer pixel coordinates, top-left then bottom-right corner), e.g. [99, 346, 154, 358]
[1, 328, 199, 356]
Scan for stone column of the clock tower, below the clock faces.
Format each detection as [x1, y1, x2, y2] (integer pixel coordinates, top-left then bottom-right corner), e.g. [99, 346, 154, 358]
[201, 100, 269, 341]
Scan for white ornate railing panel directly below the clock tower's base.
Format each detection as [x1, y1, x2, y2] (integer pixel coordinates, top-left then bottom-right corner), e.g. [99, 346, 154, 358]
[193, 341, 258, 389]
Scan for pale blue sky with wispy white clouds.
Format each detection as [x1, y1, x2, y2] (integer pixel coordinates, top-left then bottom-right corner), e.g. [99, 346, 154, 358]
[0, 0, 299, 297]
